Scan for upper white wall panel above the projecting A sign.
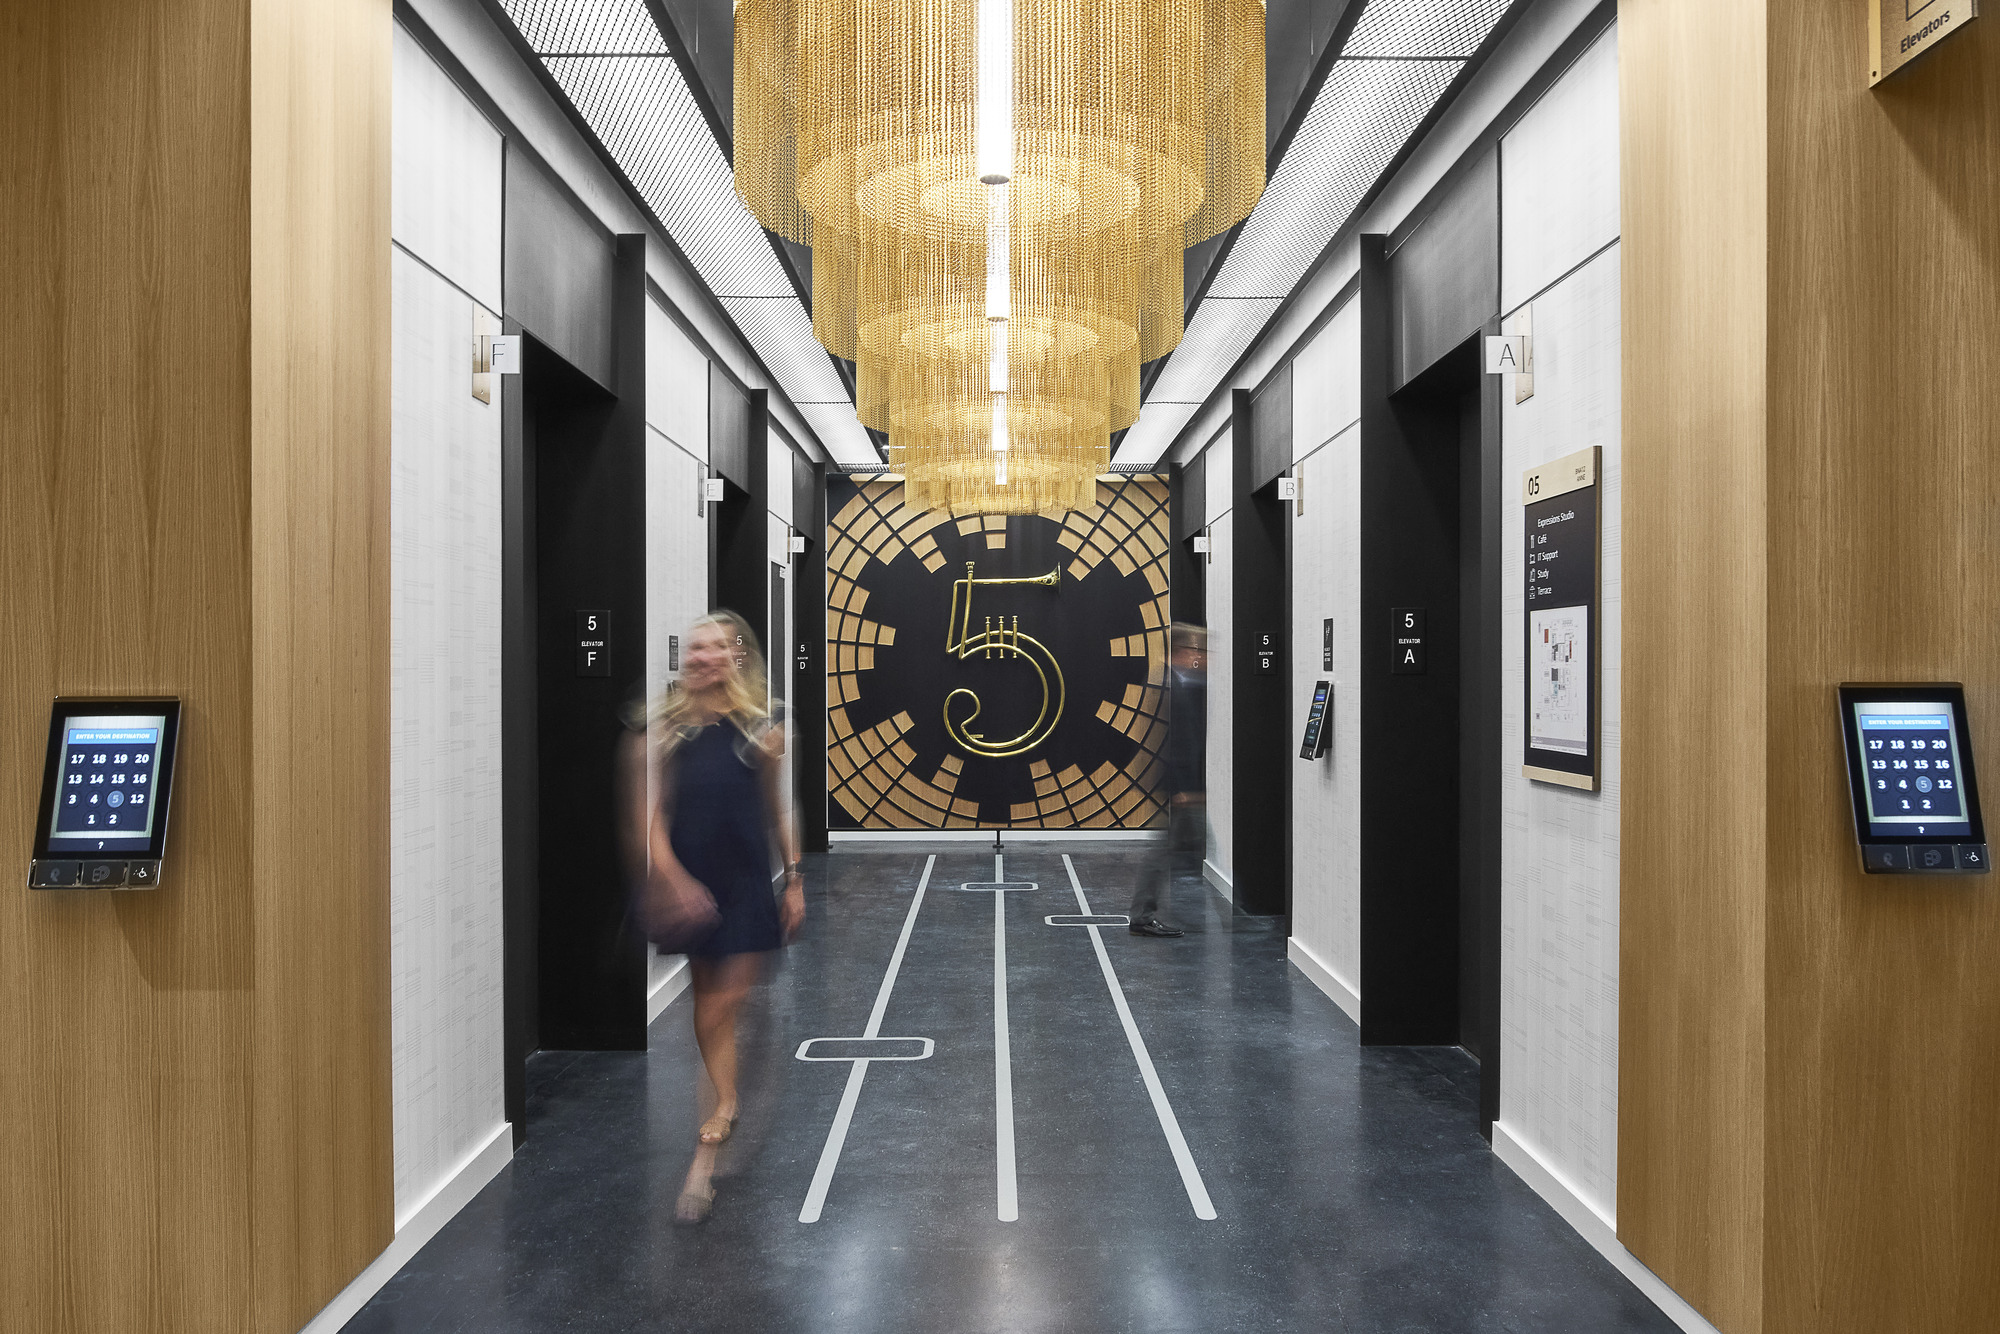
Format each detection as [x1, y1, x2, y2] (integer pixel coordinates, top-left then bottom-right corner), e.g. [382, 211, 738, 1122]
[1500, 26, 1618, 316]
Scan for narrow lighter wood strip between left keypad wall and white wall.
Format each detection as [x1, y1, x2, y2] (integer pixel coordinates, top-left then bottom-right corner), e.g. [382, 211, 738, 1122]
[248, 0, 394, 1330]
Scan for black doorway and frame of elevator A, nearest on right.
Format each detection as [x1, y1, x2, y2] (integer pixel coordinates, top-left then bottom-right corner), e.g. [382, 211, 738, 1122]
[1360, 238, 1502, 1136]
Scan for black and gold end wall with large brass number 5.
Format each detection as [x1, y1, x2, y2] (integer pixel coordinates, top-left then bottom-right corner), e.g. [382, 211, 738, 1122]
[824, 474, 1172, 830]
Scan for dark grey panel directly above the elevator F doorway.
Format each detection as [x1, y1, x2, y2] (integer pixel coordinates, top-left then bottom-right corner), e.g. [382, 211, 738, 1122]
[504, 152, 616, 390]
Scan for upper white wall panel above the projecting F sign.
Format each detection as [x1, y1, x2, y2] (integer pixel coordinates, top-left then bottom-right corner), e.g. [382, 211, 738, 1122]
[390, 24, 502, 310]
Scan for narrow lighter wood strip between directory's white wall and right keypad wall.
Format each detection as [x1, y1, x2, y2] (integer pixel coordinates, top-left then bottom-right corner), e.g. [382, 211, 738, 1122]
[1618, 0, 1770, 1334]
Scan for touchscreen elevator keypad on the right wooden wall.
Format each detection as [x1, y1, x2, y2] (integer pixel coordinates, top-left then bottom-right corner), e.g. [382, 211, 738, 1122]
[1840, 682, 1986, 876]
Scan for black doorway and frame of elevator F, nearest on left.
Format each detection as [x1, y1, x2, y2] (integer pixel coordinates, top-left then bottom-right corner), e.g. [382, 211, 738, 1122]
[500, 236, 646, 1144]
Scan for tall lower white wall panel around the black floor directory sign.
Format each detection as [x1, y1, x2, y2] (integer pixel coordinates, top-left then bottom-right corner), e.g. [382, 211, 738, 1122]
[1500, 246, 1622, 1218]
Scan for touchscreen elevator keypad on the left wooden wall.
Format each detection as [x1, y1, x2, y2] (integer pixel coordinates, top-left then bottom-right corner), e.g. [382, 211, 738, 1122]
[28, 698, 180, 890]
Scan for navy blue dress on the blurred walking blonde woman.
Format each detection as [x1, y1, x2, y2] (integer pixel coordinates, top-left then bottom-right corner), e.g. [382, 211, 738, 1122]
[668, 722, 784, 958]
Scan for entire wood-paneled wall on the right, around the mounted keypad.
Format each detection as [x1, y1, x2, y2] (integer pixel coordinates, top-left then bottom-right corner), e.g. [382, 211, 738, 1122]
[1618, 0, 2000, 1334]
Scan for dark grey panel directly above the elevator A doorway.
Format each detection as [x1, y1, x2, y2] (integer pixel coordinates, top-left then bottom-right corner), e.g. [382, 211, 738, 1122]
[1388, 148, 1500, 388]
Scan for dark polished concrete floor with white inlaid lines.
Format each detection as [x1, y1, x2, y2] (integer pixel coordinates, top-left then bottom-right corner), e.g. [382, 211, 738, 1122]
[346, 844, 1674, 1334]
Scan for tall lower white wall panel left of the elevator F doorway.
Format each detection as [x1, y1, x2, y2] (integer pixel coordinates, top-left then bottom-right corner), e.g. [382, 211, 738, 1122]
[390, 250, 506, 1226]
